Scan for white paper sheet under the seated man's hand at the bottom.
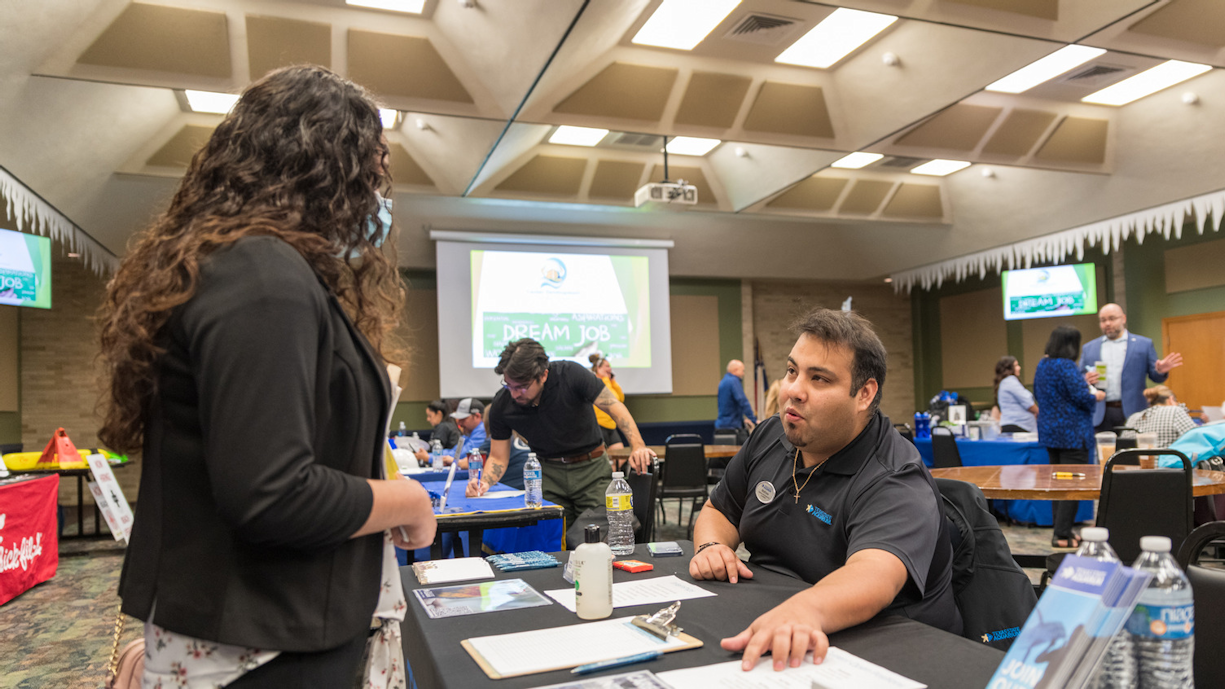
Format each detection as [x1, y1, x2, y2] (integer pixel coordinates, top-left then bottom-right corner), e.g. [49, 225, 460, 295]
[659, 646, 927, 689]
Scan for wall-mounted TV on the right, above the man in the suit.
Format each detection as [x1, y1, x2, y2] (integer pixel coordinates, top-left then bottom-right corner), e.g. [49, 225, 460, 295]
[1003, 264, 1098, 320]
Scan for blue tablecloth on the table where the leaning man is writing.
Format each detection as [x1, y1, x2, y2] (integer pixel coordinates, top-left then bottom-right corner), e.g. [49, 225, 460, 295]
[413, 471, 565, 560]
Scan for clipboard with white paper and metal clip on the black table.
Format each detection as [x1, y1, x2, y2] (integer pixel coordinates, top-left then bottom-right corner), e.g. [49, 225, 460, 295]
[459, 617, 702, 679]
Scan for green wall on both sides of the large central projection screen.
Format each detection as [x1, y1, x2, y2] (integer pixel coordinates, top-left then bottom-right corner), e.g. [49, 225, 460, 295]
[391, 271, 744, 430]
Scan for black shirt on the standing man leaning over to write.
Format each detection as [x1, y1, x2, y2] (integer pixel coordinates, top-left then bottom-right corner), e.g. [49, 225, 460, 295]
[489, 362, 604, 459]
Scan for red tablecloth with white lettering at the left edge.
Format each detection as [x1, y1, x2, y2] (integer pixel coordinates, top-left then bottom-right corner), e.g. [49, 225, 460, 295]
[0, 474, 60, 604]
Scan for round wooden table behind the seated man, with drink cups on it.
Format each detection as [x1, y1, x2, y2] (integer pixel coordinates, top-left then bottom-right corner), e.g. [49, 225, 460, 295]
[931, 465, 1225, 500]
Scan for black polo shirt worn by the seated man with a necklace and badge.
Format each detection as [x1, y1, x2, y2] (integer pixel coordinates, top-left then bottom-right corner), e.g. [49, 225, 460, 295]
[711, 413, 962, 634]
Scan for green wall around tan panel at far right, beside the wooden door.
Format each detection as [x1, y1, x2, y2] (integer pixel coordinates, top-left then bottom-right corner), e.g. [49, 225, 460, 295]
[1123, 221, 1225, 348]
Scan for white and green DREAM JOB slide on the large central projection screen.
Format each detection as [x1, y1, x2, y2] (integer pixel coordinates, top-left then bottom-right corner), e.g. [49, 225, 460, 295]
[470, 249, 650, 368]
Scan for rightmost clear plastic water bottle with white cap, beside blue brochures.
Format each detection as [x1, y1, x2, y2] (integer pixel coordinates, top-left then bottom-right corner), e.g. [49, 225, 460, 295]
[1127, 536, 1196, 689]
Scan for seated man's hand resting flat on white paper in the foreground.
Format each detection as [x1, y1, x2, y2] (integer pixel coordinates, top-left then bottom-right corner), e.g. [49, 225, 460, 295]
[720, 590, 829, 671]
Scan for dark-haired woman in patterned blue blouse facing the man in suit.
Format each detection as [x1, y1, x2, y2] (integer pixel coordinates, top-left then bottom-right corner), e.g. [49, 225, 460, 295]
[1034, 325, 1106, 548]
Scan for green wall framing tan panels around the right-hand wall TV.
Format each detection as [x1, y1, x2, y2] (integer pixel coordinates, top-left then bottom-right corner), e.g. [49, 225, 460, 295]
[910, 247, 1117, 409]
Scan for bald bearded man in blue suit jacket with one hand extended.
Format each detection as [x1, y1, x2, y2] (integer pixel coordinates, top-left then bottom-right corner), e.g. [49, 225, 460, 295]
[1080, 304, 1182, 433]
